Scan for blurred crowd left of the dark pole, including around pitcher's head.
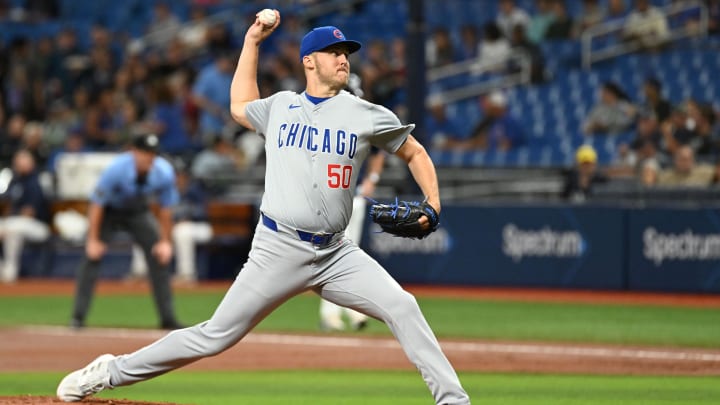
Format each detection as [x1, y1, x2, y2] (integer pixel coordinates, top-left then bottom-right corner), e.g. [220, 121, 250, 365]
[0, 0, 405, 181]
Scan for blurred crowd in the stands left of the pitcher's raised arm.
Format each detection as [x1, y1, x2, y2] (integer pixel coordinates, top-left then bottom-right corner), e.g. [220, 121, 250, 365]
[0, 2, 256, 172]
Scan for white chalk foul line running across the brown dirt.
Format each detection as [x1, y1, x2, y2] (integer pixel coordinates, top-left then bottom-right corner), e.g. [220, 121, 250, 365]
[19, 326, 720, 363]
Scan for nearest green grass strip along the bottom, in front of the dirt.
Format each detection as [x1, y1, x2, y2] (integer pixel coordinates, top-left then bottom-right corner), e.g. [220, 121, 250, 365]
[0, 371, 720, 405]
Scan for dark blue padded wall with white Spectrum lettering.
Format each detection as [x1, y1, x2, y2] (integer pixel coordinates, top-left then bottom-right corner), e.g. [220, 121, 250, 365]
[363, 206, 720, 292]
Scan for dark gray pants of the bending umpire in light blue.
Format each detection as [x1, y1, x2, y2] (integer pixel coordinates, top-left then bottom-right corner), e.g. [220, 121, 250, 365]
[72, 207, 177, 327]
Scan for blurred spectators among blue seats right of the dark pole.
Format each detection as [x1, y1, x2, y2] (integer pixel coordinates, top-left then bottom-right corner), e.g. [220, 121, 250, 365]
[426, 0, 720, 199]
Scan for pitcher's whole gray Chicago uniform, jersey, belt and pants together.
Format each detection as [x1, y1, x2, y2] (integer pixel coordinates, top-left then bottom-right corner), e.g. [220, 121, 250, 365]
[101, 92, 470, 405]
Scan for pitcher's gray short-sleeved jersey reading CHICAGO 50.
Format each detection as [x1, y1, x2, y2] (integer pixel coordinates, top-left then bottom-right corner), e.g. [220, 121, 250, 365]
[246, 91, 415, 233]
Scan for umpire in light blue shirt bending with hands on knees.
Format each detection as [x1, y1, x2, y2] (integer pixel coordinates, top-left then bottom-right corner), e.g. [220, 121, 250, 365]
[71, 134, 182, 329]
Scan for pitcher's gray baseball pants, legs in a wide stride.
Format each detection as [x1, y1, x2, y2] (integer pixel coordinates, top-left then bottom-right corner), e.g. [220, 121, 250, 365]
[109, 219, 470, 405]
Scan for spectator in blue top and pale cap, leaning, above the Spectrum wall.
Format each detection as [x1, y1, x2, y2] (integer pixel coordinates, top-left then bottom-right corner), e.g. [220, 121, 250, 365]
[437, 90, 525, 151]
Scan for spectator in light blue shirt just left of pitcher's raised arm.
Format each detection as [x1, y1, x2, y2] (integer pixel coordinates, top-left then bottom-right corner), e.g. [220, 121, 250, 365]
[193, 53, 236, 135]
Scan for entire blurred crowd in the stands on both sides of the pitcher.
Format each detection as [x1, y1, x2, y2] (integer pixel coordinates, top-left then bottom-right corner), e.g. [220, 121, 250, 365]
[0, 0, 720, 199]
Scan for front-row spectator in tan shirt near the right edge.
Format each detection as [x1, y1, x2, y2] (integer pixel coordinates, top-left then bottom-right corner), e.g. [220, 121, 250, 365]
[657, 145, 715, 187]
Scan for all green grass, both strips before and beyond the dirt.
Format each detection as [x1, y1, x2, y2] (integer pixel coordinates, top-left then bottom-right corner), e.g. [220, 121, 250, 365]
[5, 292, 720, 405]
